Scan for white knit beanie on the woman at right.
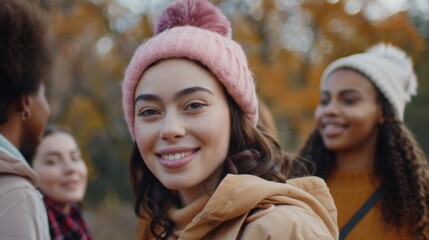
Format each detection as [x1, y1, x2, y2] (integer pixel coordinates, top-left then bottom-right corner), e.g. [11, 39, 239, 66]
[320, 43, 417, 121]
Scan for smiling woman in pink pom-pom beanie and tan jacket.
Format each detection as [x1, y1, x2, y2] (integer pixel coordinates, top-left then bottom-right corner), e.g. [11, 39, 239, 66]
[122, 0, 338, 239]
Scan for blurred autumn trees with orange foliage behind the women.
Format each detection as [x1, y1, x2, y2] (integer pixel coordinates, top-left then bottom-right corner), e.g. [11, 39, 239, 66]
[33, 0, 429, 240]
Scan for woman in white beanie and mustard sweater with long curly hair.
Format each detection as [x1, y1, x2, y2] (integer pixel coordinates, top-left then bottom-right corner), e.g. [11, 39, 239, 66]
[301, 44, 429, 240]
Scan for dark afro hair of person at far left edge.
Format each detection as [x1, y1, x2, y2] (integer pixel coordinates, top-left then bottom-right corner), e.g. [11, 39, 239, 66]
[0, 0, 51, 124]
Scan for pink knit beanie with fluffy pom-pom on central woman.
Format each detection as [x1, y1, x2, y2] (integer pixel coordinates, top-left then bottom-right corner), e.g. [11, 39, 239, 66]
[122, 0, 258, 139]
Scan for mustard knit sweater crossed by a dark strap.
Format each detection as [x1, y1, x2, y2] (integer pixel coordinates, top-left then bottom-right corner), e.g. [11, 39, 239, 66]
[327, 170, 412, 240]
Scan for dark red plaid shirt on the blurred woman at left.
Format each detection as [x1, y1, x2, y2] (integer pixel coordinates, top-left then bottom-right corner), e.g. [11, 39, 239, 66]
[43, 196, 92, 240]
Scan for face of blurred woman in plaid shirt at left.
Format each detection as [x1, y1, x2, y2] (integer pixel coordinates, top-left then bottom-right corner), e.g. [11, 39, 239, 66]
[32, 132, 88, 204]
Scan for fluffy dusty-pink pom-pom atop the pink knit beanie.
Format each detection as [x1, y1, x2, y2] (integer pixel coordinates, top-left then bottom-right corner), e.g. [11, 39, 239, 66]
[155, 0, 232, 38]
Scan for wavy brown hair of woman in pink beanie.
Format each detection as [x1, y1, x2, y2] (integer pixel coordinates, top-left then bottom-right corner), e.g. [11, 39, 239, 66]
[130, 94, 290, 239]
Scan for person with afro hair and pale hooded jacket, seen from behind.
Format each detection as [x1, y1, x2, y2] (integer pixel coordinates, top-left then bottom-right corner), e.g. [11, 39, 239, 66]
[0, 0, 50, 237]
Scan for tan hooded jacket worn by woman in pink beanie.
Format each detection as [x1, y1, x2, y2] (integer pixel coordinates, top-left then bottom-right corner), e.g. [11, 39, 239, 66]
[137, 175, 338, 240]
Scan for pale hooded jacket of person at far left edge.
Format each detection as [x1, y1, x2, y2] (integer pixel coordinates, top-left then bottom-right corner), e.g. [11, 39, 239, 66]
[0, 134, 50, 240]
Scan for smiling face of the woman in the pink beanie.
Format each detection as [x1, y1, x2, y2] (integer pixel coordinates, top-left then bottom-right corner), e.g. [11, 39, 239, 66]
[134, 59, 231, 204]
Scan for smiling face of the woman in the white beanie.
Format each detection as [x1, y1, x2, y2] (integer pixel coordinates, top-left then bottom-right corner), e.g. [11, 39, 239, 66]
[315, 69, 384, 152]
